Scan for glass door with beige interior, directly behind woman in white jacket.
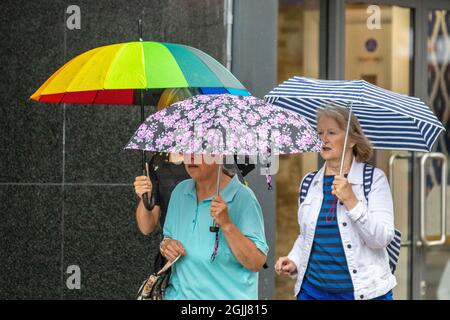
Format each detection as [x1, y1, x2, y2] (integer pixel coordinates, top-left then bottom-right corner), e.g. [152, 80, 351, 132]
[345, 1, 414, 299]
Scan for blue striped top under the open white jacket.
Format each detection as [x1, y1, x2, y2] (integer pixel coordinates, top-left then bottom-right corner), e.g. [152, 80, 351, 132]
[304, 176, 353, 293]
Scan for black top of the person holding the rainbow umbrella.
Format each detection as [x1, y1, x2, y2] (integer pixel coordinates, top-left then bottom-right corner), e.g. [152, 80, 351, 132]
[149, 154, 190, 227]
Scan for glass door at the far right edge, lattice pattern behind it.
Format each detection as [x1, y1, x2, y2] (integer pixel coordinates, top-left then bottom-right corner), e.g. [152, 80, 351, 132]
[420, 8, 450, 300]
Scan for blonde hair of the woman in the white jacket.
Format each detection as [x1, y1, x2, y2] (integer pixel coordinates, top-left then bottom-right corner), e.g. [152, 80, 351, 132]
[316, 106, 373, 162]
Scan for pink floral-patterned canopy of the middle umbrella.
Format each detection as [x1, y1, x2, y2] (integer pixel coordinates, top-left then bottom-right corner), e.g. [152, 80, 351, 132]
[125, 94, 321, 155]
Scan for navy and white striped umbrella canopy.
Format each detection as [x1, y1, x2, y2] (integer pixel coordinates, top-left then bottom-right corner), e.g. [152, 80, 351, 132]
[265, 77, 445, 152]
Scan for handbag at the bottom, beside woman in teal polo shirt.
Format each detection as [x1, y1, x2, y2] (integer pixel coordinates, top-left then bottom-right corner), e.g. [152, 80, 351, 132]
[137, 256, 180, 300]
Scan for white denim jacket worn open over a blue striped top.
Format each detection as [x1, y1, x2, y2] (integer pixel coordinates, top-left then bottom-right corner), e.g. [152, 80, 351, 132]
[288, 159, 397, 300]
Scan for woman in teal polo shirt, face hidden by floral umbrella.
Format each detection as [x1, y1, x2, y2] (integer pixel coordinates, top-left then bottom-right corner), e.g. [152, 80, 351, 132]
[160, 155, 268, 300]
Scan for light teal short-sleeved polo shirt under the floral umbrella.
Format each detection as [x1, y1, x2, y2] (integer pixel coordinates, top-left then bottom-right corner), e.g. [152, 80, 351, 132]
[164, 176, 269, 300]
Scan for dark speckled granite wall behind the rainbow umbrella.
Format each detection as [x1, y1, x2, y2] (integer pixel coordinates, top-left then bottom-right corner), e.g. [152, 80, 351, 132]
[0, 0, 225, 299]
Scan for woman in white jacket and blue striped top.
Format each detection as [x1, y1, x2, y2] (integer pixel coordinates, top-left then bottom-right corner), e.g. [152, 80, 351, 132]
[275, 107, 396, 300]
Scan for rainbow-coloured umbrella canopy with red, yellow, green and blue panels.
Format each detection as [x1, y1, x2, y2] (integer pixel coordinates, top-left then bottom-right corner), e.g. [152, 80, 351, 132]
[31, 41, 249, 105]
